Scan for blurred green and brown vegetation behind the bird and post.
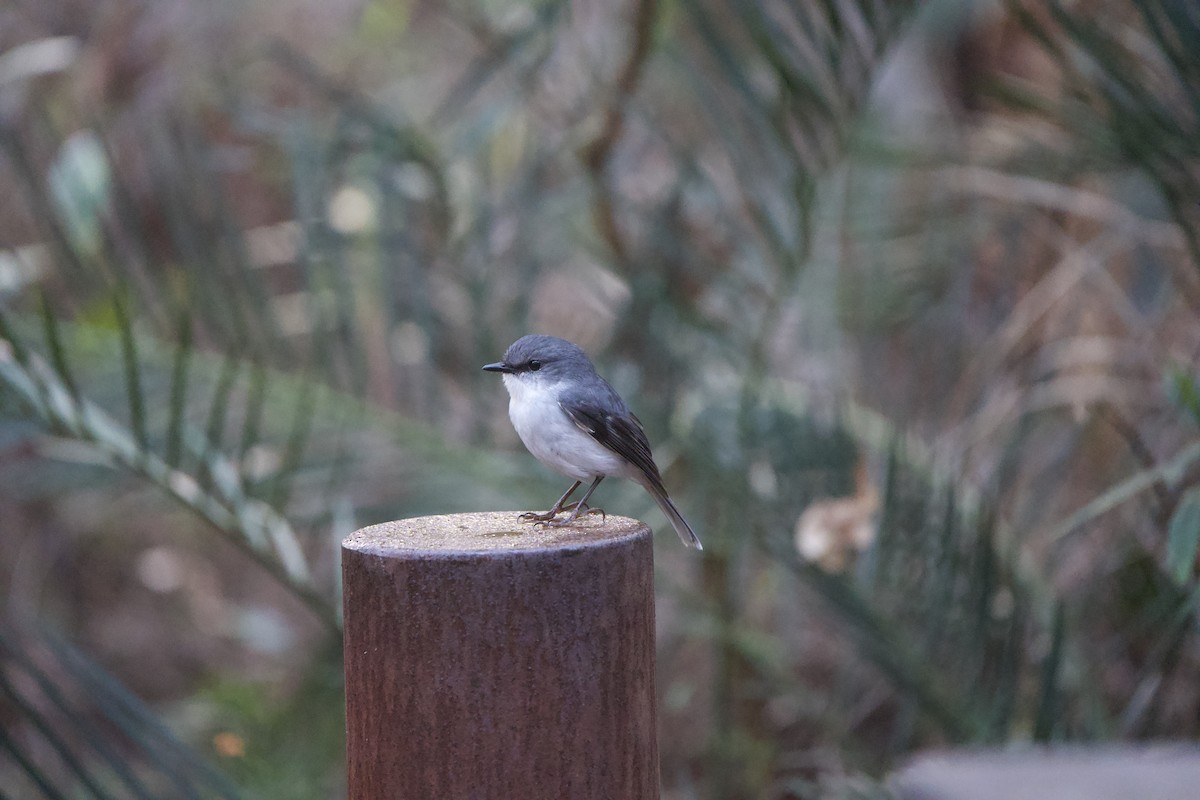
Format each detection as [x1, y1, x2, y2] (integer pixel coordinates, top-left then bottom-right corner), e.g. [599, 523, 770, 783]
[0, 0, 1200, 799]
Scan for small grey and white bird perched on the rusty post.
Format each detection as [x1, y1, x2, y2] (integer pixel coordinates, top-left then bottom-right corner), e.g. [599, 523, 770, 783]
[484, 333, 703, 549]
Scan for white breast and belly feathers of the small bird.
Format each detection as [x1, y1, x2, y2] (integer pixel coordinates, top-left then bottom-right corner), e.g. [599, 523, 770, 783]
[504, 373, 626, 481]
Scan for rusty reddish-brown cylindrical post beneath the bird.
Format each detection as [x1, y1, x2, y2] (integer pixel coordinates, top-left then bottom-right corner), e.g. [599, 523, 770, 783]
[342, 512, 659, 800]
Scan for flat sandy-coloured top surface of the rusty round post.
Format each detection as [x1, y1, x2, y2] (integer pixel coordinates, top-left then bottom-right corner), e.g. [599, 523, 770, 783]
[342, 511, 650, 554]
